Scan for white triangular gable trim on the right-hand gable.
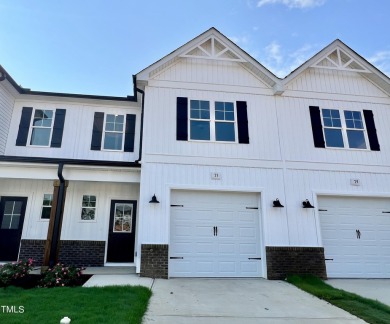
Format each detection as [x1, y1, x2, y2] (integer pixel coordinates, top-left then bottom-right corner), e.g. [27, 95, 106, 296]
[311, 48, 372, 73]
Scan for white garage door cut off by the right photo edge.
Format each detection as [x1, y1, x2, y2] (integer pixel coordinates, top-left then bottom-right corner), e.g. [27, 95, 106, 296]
[318, 197, 390, 278]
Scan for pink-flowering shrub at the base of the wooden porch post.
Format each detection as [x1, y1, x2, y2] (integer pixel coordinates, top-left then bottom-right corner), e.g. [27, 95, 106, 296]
[39, 263, 85, 288]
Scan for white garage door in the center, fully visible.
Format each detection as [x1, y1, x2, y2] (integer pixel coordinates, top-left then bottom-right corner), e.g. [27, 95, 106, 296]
[169, 190, 262, 277]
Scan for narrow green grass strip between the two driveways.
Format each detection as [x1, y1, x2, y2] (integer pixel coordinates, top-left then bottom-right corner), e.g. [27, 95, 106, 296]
[287, 275, 390, 324]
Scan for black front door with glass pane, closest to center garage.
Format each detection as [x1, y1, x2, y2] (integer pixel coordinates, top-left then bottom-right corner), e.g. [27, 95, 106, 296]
[107, 200, 137, 262]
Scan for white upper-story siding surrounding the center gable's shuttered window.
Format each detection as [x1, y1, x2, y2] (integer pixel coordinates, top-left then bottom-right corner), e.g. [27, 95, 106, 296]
[143, 87, 281, 166]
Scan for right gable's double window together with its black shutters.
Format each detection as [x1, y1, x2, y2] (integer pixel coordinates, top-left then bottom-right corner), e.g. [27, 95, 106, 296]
[309, 106, 380, 151]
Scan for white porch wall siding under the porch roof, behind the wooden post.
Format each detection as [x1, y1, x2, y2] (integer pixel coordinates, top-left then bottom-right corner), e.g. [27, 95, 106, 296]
[0, 179, 139, 241]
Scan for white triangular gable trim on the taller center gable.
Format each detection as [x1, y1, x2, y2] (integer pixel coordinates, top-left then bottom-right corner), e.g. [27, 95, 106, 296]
[180, 36, 247, 62]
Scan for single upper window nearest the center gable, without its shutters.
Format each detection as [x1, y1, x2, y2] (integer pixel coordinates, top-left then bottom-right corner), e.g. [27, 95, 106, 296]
[103, 114, 125, 151]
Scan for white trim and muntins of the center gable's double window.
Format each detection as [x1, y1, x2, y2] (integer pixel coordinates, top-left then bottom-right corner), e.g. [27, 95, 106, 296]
[187, 98, 238, 144]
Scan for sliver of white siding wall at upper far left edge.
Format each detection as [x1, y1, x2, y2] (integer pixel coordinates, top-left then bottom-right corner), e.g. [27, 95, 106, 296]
[0, 81, 15, 155]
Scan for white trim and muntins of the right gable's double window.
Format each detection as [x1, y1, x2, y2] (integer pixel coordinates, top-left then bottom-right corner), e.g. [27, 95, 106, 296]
[321, 108, 370, 151]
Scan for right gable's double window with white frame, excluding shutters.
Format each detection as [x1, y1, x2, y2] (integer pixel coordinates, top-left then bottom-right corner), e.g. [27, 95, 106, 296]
[322, 109, 367, 149]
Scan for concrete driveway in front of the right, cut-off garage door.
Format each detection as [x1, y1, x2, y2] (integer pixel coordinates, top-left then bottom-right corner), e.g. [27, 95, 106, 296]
[326, 279, 390, 306]
